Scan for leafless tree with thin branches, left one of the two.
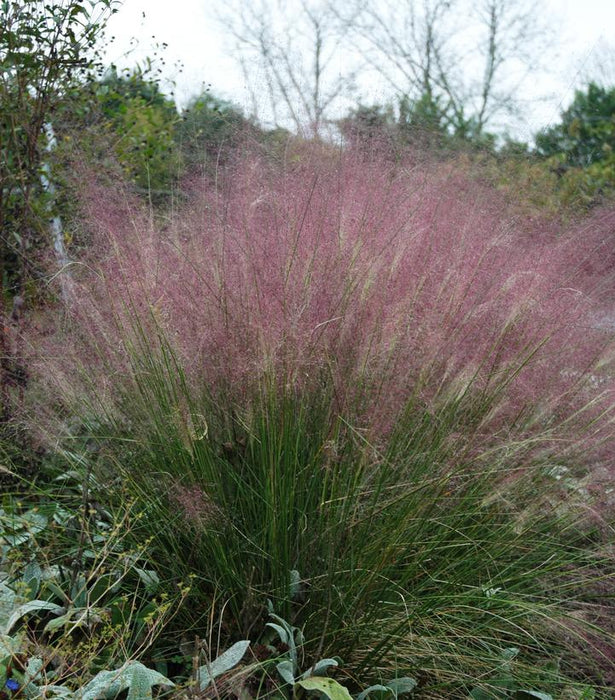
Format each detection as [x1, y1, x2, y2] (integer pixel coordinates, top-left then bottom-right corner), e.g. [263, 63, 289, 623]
[218, 0, 354, 136]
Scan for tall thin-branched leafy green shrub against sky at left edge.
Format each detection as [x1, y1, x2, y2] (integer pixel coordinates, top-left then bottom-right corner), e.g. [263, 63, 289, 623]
[0, 0, 117, 292]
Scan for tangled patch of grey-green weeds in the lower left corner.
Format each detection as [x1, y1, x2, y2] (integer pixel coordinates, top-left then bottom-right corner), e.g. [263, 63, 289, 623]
[0, 464, 187, 698]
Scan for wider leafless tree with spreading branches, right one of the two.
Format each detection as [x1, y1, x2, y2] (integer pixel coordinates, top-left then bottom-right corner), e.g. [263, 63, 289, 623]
[346, 0, 548, 134]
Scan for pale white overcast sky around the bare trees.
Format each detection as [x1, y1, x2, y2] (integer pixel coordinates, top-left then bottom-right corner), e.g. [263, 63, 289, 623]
[107, 0, 615, 140]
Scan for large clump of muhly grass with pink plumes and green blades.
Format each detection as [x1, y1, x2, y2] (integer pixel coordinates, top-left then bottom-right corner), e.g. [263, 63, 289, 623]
[26, 149, 615, 697]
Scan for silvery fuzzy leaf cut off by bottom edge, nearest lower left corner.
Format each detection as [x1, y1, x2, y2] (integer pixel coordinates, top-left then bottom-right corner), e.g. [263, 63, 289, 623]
[77, 661, 175, 700]
